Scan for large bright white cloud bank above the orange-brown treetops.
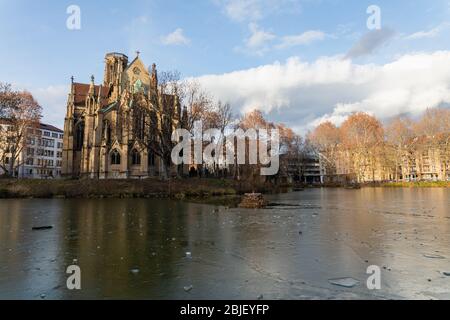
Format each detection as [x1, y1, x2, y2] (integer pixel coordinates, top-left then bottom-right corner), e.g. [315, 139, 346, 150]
[194, 51, 450, 132]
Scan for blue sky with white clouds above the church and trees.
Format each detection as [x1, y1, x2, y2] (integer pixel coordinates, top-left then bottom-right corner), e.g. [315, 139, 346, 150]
[0, 0, 450, 133]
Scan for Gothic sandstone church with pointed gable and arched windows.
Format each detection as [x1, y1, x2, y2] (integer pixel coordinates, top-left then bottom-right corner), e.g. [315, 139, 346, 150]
[62, 52, 182, 179]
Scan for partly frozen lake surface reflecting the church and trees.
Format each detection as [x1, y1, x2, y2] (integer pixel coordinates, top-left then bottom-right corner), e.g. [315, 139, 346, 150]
[0, 189, 450, 299]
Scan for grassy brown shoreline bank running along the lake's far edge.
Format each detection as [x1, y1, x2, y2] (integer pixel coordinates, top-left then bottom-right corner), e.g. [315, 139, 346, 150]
[0, 178, 450, 200]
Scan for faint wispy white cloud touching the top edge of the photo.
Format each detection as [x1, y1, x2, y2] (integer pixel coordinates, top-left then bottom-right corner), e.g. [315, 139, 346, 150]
[214, 0, 300, 22]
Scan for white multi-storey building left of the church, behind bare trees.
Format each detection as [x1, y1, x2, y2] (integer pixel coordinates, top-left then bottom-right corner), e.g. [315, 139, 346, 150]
[0, 122, 64, 179]
